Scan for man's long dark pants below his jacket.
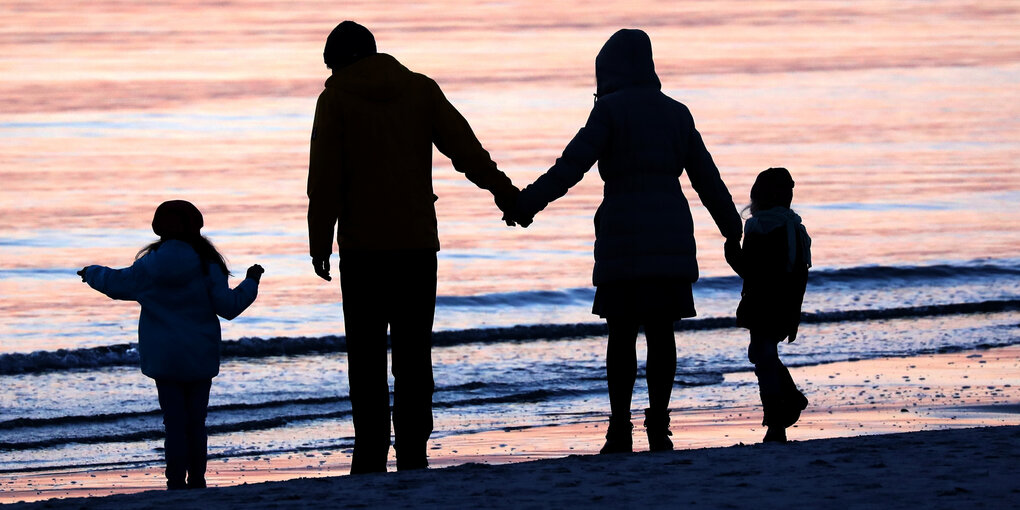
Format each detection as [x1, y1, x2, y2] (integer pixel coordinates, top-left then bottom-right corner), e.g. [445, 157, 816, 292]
[340, 250, 437, 473]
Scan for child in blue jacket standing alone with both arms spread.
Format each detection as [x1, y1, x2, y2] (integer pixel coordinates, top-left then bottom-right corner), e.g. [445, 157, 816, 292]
[78, 200, 264, 490]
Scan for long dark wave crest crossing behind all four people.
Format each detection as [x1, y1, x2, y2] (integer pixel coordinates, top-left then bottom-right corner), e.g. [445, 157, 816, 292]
[0, 299, 1020, 375]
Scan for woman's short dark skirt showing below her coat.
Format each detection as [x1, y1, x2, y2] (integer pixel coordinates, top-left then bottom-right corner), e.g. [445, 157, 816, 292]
[592, 277, 698, 321]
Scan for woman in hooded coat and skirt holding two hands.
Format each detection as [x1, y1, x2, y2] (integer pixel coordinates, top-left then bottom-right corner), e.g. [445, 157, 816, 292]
[514, 30, 741, 453]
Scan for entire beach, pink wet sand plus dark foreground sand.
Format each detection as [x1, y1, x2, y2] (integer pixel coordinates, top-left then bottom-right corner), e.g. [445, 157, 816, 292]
[0, 346, 1020, 508]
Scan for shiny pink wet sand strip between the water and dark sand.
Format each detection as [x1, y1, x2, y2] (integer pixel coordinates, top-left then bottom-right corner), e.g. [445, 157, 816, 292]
[0, 346, 1020, 503]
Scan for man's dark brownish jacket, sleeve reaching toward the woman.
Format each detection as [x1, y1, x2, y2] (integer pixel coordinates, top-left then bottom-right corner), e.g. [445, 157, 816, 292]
[308, 53, 516, 258]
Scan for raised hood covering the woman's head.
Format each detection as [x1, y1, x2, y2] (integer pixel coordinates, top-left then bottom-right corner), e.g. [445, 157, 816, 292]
[595, 29, 662, 97]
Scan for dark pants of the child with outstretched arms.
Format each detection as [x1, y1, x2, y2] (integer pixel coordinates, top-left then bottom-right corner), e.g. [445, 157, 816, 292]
[156, 379, 212, 489]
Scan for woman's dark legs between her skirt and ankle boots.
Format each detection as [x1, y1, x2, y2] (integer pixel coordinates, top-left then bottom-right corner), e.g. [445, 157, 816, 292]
[606, 317, 676, 420]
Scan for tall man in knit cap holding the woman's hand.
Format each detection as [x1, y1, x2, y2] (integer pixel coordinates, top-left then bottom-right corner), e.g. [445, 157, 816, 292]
[308, 21, 518, 473]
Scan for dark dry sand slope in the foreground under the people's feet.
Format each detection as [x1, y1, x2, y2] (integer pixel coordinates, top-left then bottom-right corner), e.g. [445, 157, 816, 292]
[7, 426, 1020, 509]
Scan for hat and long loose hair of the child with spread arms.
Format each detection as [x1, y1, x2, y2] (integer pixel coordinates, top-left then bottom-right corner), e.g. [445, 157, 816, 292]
[135, 200, 231, 274]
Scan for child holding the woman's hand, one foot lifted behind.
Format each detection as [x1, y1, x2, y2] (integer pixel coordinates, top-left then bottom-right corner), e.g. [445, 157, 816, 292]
[725, 168, 811, 443]
